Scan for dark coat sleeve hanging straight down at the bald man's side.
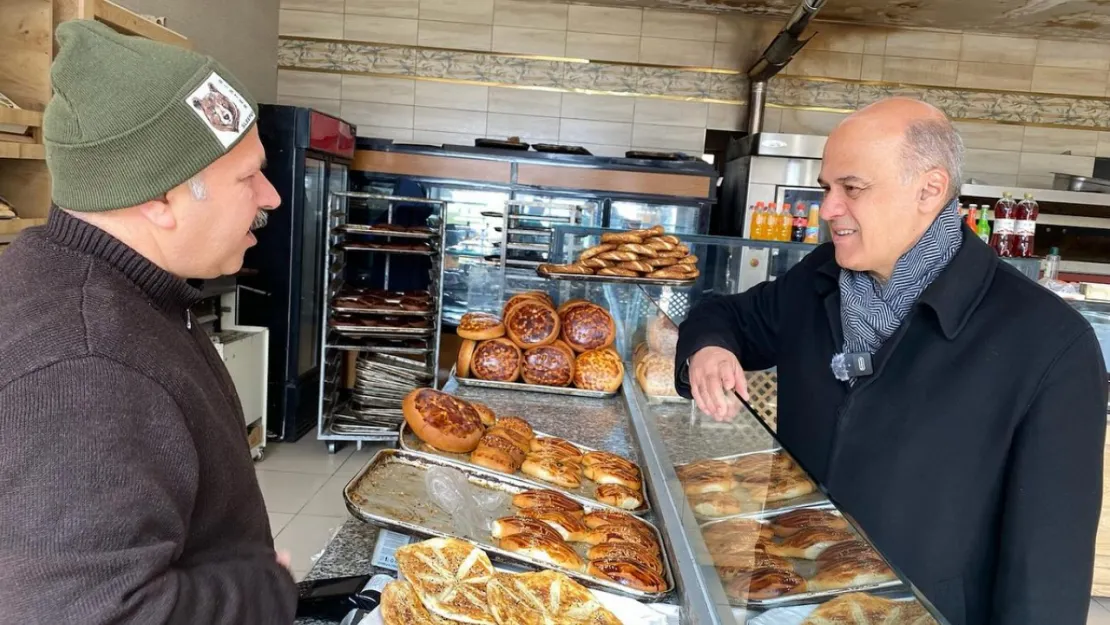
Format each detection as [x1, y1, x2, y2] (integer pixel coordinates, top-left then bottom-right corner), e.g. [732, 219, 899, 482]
[990, 329, 1107, 625]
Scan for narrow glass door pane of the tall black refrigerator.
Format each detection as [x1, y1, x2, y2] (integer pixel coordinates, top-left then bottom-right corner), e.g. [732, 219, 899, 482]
[296, 159, 326, 375]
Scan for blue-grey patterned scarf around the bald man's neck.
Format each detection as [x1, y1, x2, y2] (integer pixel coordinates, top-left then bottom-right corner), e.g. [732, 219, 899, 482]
[840, 201, 963, 368]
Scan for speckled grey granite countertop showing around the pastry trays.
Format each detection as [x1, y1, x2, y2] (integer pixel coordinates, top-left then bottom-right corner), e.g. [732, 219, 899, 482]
[295, 382, 650, 625]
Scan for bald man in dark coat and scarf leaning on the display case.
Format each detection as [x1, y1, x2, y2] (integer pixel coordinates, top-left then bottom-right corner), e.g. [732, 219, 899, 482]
[676, 99, 1107, 625]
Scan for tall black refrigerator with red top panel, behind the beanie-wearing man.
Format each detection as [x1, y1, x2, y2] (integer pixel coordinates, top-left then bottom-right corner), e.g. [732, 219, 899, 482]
[240, 104, 355, 442]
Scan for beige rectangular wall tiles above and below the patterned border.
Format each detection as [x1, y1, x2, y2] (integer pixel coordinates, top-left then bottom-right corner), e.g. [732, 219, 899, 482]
[278, 0, 1110, 187]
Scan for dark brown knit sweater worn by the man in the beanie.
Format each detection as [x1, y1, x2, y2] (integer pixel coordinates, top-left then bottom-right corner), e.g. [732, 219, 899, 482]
[0, 209, 296, 625]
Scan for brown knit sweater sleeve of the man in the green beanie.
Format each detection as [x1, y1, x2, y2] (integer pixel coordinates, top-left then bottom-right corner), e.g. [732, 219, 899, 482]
[0, 357, 296, 625]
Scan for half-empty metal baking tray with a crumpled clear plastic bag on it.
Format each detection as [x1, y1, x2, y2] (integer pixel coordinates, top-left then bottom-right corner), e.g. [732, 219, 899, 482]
[343, 450, 675, 602]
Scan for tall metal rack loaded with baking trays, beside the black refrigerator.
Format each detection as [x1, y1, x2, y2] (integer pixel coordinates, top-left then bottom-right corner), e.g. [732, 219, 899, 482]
[316, 191, 446, 453]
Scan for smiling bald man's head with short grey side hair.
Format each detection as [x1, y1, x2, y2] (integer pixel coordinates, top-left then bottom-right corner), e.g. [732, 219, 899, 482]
[820, 98, 963, 279]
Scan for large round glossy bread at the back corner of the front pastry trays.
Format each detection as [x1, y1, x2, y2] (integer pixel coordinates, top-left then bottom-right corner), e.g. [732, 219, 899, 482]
[401, 389, 485, 454]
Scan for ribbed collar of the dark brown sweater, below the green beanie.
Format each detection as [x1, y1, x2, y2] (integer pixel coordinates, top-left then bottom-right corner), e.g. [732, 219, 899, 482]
[46, 206, 201, 314]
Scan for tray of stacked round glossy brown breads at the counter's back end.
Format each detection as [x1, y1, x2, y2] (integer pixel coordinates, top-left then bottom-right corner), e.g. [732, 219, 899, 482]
[453, 291, 625, 397]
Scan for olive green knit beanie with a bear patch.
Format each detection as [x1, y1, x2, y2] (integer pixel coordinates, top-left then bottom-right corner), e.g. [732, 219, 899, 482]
[42, 20, 258, 212]
